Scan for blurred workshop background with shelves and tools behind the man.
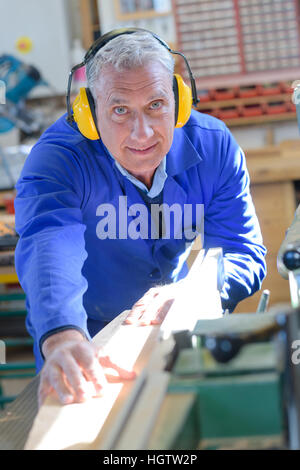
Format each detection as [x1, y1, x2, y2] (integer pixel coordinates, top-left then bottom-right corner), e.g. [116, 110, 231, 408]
[0, 0, 300, 407]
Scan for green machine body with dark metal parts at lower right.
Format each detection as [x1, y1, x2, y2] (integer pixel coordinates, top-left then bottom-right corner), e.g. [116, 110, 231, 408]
[189, 304, 300, 449]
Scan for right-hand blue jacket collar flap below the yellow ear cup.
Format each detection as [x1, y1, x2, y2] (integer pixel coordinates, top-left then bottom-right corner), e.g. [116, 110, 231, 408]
[166, 129, 202, 176]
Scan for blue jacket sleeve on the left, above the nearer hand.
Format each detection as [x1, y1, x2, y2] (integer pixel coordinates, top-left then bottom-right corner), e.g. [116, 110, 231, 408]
[15, 143, 89, 356]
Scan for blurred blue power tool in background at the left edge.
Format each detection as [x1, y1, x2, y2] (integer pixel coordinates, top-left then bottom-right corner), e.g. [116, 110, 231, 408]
[0, 55, 47, 135]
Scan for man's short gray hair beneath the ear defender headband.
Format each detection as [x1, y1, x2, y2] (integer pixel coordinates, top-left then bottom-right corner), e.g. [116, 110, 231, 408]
[86, 31, 174, 98]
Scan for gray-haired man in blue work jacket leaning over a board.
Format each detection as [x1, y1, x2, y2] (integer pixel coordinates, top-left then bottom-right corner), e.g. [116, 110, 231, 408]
[15, 31, 265, 403]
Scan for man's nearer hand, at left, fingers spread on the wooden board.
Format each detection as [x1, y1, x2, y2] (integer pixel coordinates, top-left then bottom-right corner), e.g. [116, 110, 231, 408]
[38, 330, 135, 405]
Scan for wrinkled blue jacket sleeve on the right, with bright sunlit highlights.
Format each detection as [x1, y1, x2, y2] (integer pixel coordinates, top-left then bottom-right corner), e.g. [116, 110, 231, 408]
[204, 128, 266, 312]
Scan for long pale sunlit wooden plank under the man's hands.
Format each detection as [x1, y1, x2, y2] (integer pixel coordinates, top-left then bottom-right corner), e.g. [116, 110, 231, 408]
[25, 248, 222, 449]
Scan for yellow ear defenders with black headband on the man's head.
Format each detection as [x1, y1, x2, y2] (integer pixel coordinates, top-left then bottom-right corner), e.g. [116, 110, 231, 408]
[67, 28, 199, 140]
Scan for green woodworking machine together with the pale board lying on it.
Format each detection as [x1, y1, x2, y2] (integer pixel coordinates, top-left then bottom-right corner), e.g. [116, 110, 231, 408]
[0, 249, 300, 450]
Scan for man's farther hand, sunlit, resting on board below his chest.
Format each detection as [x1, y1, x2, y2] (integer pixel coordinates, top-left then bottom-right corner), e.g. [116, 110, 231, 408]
[124, 281, 184, 325]
